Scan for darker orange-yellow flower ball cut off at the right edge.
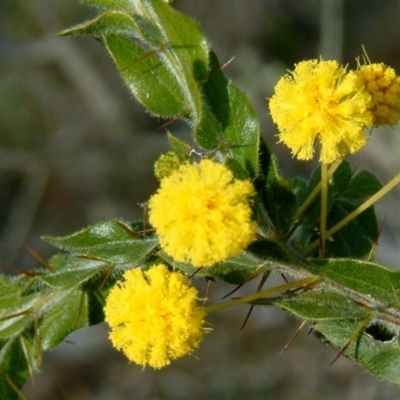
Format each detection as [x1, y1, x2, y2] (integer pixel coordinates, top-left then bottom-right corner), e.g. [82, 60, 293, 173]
[356, 63, 400, 126]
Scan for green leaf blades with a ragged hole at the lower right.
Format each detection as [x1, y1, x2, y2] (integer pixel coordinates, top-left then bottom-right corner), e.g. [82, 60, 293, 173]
[252, 259, 400, 386]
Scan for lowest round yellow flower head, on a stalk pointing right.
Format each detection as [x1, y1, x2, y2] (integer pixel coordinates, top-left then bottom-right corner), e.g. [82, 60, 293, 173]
[104, 264, 205, 368]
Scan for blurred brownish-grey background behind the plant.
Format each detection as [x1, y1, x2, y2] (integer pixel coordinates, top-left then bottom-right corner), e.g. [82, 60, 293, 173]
[0, 0, 400, 400]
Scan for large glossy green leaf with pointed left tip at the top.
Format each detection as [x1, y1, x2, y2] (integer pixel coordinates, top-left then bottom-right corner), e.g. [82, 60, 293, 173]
[61, 0, 209, 120]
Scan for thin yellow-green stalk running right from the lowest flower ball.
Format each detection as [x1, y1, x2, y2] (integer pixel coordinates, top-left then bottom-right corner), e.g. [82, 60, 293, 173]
[205, 276, 321, 314]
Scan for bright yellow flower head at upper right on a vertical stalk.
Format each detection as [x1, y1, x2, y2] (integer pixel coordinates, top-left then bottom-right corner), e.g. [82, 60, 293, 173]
[269, 60, 372, 164]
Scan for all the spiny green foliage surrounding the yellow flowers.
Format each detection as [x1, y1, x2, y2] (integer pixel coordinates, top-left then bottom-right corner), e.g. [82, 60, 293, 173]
[0, 0, 400, 399]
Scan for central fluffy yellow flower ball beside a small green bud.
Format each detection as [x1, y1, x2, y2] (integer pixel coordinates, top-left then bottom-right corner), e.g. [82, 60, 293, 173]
[149, 160, 257, 267]
